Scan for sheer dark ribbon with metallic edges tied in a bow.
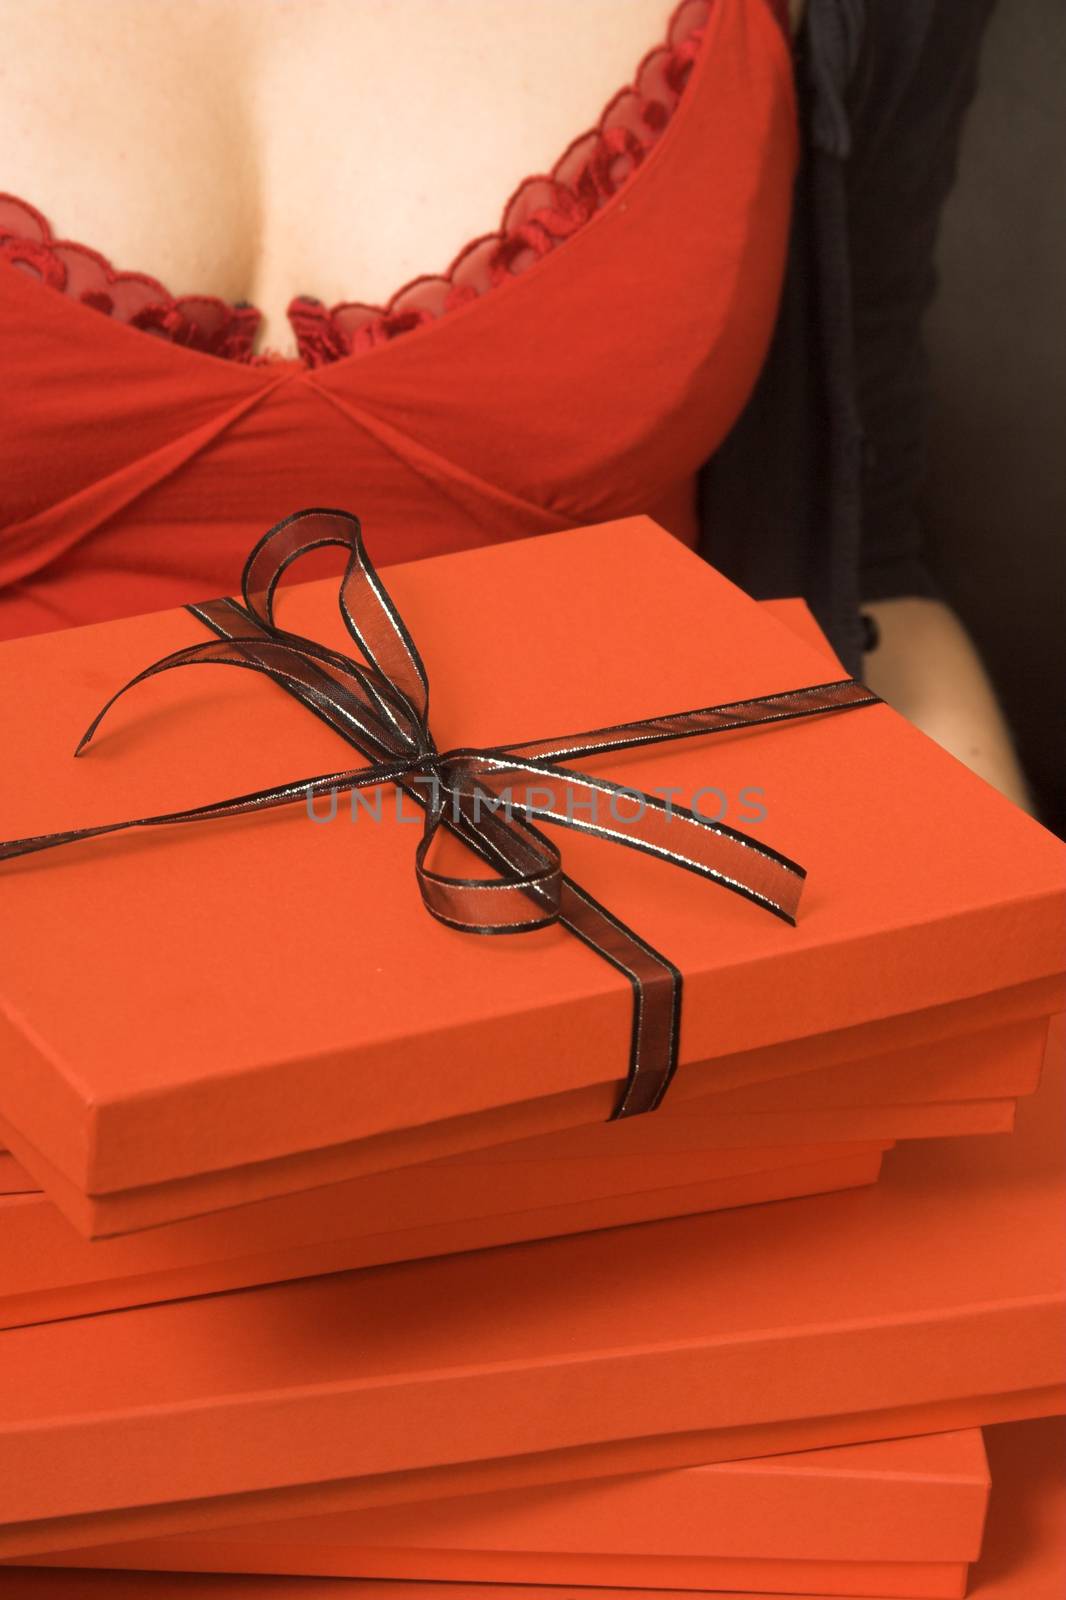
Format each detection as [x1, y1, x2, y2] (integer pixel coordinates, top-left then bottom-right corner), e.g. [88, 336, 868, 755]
[0, 509, 877, 1117]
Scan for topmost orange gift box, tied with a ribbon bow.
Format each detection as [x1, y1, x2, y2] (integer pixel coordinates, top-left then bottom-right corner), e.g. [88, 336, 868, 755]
[0, 514, 1064, 1216]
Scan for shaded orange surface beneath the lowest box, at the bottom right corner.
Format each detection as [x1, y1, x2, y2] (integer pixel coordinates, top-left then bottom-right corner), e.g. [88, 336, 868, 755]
[0, 1418, 1066, 1600]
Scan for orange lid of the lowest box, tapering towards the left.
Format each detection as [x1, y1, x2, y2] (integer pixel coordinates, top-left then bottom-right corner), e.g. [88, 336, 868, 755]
[56, 1429, 989, 1582]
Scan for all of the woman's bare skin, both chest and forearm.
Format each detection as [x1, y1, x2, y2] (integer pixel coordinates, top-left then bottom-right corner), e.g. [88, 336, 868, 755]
[0, 0, 1029, 805]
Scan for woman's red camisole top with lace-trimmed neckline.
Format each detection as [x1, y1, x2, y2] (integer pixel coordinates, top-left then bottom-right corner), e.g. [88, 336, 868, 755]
[0, 0, 799, 638]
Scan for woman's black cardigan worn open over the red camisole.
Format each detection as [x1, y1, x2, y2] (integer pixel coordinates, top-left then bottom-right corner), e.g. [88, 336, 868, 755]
[698, 0, 994, 674]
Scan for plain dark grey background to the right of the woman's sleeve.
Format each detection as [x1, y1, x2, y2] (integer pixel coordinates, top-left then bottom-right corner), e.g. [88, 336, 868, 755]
[922, 0, 1066, 835]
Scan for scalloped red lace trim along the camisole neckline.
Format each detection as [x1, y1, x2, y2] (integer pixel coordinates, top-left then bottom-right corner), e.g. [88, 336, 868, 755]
[0, 0, 777, 366]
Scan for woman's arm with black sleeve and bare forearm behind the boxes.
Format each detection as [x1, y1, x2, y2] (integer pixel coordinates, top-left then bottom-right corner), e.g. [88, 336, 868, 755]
[847, 0, 1032, 810]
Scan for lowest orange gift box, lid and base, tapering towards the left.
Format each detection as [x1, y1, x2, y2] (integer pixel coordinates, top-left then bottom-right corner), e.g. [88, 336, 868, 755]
[18, 1429, 989, 1595]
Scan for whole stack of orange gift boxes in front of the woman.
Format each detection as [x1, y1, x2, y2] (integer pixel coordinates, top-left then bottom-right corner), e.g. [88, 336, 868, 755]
[0, 514, 1066, 1600]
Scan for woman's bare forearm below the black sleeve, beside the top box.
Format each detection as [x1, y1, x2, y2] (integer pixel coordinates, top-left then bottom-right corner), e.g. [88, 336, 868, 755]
[863, 597, 1032, 811]
